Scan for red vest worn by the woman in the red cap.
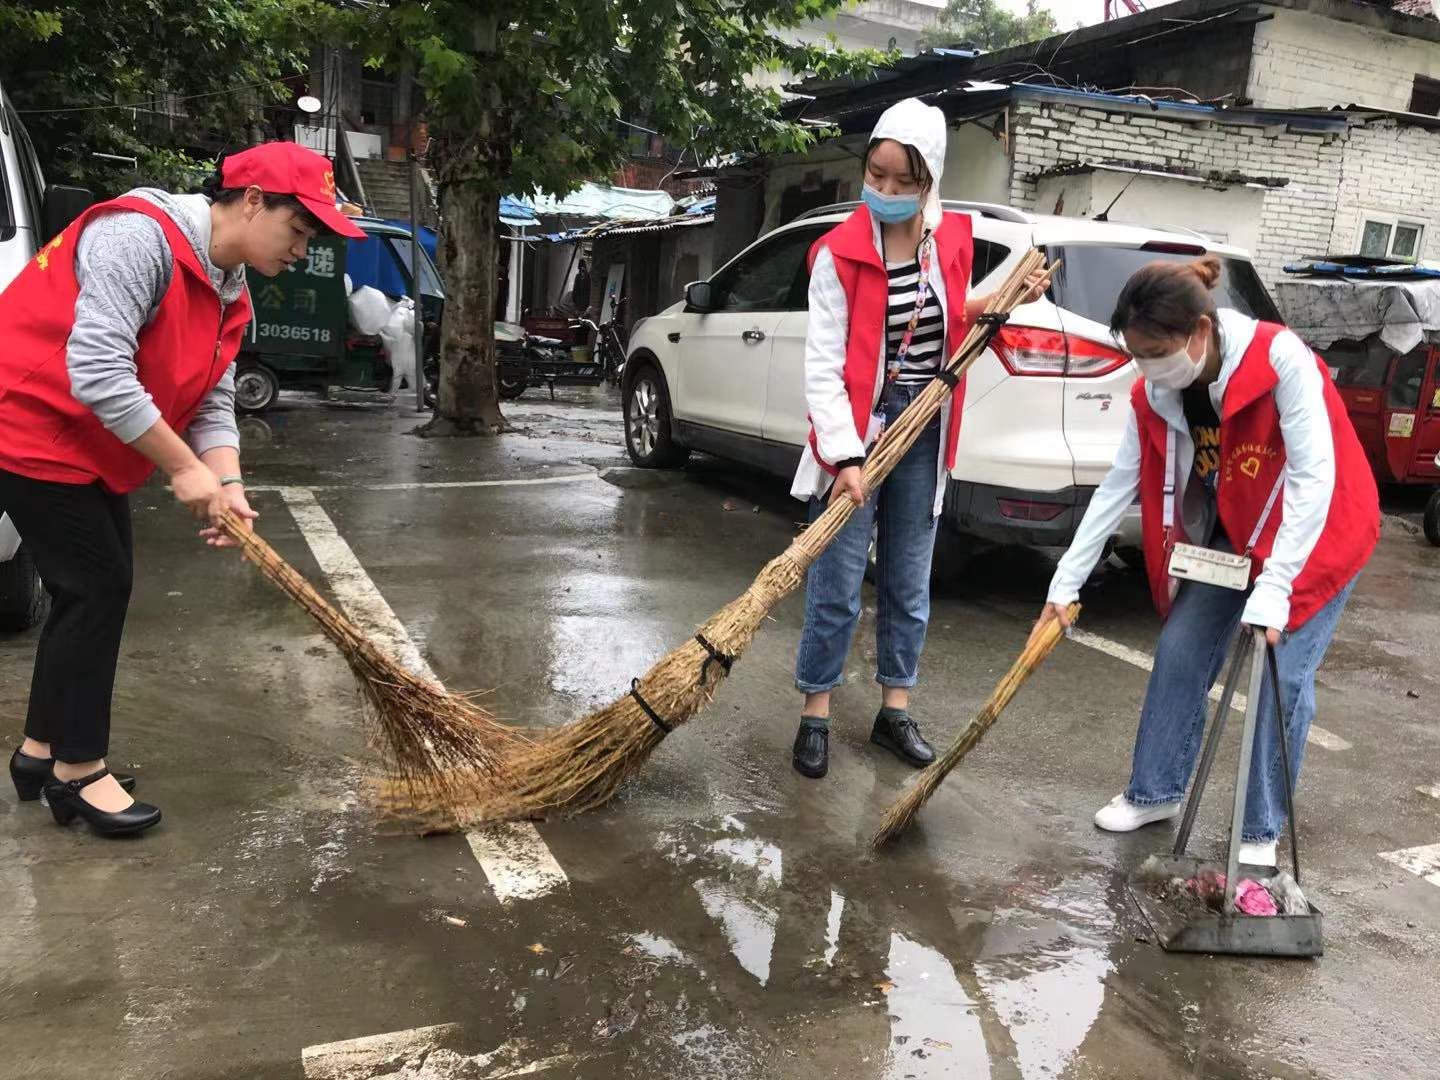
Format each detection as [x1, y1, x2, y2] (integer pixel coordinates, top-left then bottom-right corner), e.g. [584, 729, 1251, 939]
[0, 196, 251, 494]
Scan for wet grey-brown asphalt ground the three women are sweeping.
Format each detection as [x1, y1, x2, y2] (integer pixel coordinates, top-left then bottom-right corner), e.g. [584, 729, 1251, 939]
[0, 390, 1440, 1080]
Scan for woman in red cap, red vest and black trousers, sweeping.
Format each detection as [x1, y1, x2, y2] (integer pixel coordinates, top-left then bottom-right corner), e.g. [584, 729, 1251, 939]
[0, 143, 363, 835]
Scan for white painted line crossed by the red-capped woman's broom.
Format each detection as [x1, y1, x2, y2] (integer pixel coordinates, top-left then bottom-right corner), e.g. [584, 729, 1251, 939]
[281, 488, 567, 903]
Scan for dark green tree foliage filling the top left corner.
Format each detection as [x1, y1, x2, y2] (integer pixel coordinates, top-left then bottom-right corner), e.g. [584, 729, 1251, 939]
[0, 0, 331, 194]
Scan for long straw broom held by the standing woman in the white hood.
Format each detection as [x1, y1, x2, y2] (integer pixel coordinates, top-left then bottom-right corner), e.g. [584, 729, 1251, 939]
[452, 251, 1045, 821]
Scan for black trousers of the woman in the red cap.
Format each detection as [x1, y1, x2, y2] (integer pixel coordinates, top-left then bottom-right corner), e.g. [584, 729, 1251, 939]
[0, 469, 134, 762]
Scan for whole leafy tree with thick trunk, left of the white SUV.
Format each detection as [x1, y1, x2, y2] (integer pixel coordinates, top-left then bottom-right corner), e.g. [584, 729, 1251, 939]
[354, 0, 883, 433]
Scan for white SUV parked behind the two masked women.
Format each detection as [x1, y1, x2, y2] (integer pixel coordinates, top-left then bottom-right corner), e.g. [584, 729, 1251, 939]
[622, 200, 1279, 546]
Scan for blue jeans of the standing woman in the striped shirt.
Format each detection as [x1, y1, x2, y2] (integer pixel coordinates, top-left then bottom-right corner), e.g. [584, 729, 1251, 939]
[795, 383, 940, 694]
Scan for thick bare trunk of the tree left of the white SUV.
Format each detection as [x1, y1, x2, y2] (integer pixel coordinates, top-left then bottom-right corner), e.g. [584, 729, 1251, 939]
[422, 180, 507, 435]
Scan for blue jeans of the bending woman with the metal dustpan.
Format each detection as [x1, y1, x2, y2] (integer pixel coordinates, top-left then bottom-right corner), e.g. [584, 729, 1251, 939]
[1125, 580, 1355, 841]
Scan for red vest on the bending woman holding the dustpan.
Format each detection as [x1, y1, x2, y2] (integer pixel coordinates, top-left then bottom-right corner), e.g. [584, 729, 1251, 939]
[1130, 323, 1380, 631]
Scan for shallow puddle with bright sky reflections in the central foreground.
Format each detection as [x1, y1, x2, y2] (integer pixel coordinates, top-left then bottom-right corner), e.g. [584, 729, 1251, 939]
[628, 812, 1283, 1080]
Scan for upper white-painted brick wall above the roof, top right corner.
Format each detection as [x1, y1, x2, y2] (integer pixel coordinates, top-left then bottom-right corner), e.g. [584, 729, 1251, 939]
[1248, 9, 1440, 111]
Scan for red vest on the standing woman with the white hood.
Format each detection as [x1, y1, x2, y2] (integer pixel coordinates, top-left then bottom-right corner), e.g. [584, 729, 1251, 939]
[809, 206, 975, 474]
